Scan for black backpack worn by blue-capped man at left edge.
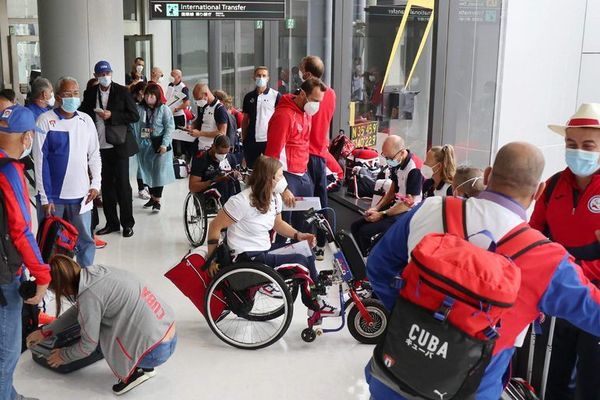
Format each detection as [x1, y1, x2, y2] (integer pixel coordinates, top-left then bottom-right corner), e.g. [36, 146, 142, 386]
[0, 158, 23, 288]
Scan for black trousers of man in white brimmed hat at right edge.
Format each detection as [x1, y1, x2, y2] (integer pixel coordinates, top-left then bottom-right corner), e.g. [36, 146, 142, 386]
[548, 318, 600, 400]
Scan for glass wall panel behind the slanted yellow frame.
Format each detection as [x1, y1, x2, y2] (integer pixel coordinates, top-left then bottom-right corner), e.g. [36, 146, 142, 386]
[350, 0, 432, 156]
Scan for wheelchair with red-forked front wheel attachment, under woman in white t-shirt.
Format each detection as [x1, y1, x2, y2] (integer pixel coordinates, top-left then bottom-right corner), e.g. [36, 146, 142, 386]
[204, 210, 388, 349]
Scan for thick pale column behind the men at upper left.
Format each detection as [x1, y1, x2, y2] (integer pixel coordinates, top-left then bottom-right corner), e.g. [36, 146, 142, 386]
[38, 0, 126, 89]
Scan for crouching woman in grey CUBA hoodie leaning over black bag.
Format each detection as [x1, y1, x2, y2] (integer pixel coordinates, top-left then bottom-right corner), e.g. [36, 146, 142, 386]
[27, 255, 177, 395]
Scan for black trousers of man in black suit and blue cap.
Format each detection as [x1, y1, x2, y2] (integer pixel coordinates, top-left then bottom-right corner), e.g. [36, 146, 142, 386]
[100, 149, 135, 228]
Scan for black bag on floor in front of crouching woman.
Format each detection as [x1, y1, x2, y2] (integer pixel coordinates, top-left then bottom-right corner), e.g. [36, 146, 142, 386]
[31, 324, 104, 374]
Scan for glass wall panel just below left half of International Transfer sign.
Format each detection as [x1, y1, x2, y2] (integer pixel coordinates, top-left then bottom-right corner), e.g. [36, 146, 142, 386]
[172, 20, 209, 87]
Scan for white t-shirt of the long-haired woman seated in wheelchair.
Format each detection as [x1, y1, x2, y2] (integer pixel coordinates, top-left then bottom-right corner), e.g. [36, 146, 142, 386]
[223, 188, 283, 256]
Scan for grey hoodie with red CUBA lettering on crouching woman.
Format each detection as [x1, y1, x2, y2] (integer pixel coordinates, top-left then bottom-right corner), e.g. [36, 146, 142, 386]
[43, 265, 174, 381]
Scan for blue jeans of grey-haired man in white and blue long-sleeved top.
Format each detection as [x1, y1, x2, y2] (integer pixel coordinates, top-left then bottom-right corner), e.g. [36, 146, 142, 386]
[37, 199, 96, 267]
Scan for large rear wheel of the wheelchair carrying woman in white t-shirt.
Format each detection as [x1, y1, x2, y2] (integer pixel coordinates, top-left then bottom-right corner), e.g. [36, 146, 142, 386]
[205, 263, 294, 350]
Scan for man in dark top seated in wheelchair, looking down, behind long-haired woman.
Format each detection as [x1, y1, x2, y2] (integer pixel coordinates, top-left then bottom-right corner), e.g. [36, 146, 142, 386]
[189, 135, 241, 208]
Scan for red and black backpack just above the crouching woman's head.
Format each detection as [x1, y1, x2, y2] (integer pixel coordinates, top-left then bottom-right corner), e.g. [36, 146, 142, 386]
[37, 215, 79, 263]
